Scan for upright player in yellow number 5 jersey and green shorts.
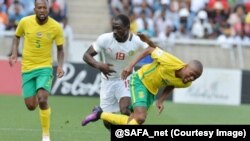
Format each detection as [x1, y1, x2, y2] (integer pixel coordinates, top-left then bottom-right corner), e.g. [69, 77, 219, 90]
[9, 0, 64, 141]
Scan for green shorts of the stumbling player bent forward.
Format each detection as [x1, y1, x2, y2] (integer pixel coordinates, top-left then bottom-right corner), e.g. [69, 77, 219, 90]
[130, 73, 155, 110]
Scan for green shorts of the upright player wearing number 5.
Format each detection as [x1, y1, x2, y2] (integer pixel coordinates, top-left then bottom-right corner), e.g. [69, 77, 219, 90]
[22, 68, 53, 98]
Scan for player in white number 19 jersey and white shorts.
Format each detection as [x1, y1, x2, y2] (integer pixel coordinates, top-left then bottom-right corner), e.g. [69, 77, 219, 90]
[82, 14, 152, 129]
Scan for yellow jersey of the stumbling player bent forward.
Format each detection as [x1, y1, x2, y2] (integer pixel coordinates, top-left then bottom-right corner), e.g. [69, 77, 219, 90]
[137, 47, 191, 95]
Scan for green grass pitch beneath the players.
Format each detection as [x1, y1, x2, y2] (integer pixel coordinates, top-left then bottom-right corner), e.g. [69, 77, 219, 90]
[0, 96, 250, 141]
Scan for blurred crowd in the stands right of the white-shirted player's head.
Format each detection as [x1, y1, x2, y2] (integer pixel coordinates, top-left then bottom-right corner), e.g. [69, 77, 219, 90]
[108, 0, 250, 47]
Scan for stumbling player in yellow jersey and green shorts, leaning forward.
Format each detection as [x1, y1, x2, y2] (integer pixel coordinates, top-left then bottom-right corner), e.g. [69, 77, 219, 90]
[84, 35, 203, 125]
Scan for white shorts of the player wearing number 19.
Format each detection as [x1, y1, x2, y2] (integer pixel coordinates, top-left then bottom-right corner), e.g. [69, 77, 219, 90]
[100, 78, 130, 112]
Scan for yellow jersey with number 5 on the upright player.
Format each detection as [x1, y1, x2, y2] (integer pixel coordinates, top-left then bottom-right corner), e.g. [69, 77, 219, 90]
[15, 15, 64, 72]
